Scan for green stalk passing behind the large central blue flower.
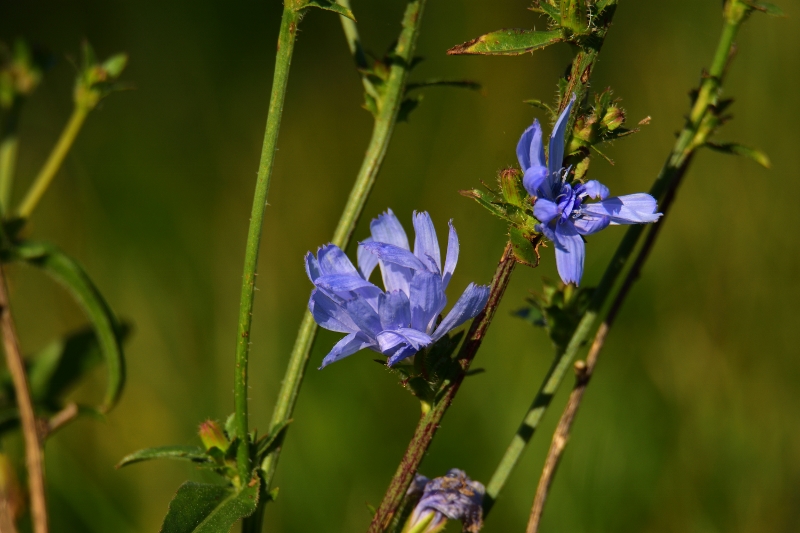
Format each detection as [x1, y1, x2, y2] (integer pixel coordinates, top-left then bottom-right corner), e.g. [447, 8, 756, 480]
[261, 0, 426, 487]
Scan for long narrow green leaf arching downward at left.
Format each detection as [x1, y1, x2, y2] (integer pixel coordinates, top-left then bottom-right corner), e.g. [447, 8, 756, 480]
[13, 241, 125, 412]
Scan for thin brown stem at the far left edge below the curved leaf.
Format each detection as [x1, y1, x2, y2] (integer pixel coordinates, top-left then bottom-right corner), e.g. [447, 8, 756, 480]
[0, 264, 48, 533]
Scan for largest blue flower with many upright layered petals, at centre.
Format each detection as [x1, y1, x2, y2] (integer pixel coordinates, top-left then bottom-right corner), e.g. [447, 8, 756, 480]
[306, 210, 489, 368]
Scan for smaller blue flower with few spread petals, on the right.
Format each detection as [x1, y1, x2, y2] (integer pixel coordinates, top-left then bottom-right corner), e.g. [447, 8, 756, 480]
[517, 95, 661, 285]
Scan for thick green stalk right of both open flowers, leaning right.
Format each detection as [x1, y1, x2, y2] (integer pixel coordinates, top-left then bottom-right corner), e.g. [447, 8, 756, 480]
[484, 4, 745, 514]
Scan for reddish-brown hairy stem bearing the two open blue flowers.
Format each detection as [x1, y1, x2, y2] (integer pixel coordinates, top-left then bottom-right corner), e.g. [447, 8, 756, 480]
[369, 12, 614, 533]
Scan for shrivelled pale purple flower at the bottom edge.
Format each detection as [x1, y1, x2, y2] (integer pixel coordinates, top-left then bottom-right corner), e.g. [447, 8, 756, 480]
[403, 468, 486, 533]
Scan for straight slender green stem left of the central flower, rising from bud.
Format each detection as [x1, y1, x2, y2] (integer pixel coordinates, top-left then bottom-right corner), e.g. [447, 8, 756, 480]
[234, 5, 300, 484]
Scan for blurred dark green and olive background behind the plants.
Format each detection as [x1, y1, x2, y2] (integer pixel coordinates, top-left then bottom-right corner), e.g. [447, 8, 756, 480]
[0, 0, 800, 533]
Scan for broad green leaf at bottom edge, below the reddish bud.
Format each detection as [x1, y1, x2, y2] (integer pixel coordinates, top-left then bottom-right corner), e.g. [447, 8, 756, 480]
[161, 477, 260, 533]
